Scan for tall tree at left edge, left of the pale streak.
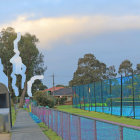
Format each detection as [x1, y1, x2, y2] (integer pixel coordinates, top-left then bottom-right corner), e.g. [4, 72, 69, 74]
[0, 27, 16, 96]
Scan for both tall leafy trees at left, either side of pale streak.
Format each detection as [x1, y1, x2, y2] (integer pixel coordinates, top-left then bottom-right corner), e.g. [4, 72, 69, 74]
[0, 27, 46, 107]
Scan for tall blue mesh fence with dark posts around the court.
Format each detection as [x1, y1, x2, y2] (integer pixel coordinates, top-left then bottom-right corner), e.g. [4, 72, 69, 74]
[73, 75, 140, 119]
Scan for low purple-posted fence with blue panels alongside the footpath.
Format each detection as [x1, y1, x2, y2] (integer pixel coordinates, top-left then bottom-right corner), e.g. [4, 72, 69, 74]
[32, 105, 140, 140]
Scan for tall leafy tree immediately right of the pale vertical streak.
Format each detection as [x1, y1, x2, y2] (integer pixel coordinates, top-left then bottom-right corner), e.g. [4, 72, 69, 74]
[19, 33, 46, 107]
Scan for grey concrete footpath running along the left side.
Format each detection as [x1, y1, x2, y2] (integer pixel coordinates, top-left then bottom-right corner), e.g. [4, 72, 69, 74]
[11, 110, 49, 140]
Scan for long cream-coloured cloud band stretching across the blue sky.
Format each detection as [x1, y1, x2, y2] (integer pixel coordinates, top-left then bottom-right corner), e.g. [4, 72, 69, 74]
[0, 15, 140, 49]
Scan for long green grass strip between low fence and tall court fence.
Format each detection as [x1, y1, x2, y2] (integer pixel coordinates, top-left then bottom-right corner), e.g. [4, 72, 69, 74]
[57, 105, 140, 127]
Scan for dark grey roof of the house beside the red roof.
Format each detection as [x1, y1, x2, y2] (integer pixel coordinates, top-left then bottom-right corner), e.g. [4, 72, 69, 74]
[54, 88, 73, 96]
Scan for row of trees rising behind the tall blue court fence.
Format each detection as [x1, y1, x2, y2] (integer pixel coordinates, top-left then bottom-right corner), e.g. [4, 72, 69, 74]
[69, 54, 140, 86]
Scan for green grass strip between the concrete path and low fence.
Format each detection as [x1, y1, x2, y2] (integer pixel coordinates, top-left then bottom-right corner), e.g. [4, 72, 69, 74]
[38, 122, 62, 140]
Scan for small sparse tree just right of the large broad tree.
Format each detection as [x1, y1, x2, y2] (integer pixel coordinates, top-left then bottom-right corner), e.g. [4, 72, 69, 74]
[106, 66, 117, 79]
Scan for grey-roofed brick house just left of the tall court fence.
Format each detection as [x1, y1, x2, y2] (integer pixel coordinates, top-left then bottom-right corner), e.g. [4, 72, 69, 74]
[53, 88, 73, 105]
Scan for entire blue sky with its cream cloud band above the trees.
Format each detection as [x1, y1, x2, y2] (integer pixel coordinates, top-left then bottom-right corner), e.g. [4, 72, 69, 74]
[0, 0, 140, 87]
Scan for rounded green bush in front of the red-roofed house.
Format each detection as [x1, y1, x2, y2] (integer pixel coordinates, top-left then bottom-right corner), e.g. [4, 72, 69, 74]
[33, 91, 55, 108]
